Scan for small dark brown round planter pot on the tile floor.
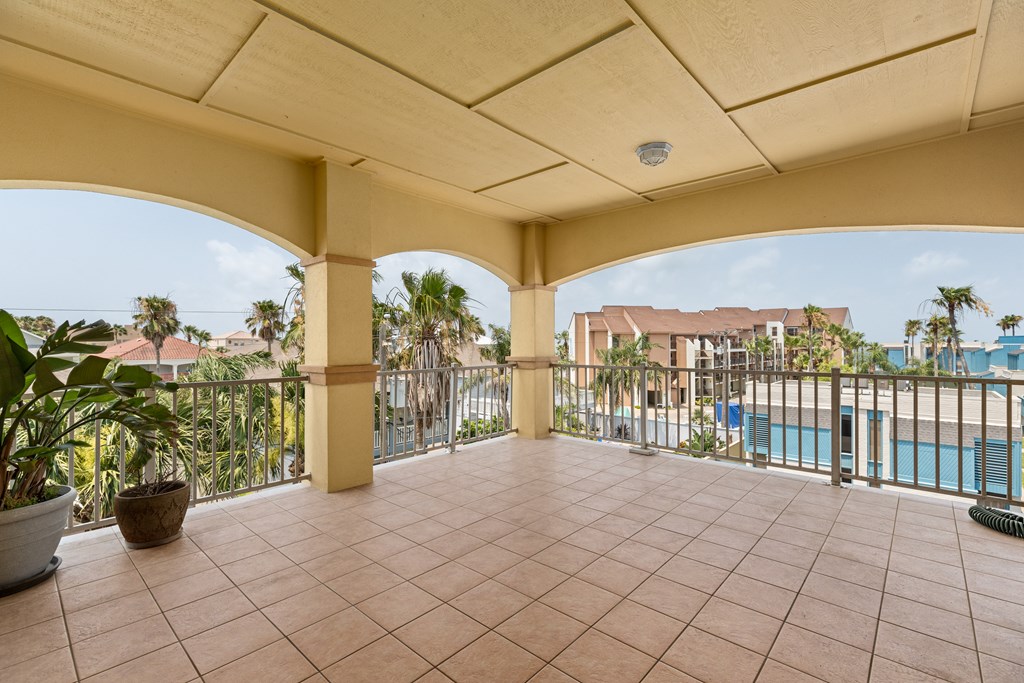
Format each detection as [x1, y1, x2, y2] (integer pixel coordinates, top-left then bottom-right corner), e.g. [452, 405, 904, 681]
[114, 481, 188, 548]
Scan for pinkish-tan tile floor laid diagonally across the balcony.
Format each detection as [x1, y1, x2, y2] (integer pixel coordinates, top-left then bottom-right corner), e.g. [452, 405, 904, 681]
[0, 438, 1024, 683]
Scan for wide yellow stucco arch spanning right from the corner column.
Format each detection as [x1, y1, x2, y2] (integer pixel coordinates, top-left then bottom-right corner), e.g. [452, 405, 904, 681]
[544, 124, 1024, 286]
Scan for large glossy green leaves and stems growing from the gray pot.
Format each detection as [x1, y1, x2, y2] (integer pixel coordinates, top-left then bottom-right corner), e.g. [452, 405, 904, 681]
[0, 309, 177, 511]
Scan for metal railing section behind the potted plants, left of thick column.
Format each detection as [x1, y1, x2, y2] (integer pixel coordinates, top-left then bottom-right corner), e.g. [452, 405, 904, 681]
[58, 377, 309, 532]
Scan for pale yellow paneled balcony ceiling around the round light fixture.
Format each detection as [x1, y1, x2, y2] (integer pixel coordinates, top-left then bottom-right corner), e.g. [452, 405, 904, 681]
[0, 0, 1024, 222]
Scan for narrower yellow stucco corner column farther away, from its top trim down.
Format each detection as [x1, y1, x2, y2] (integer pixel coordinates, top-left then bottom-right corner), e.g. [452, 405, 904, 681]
[509, 285, 557, 438]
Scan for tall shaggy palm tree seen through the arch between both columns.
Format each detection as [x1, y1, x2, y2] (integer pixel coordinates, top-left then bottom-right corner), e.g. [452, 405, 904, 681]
[392, 268, 483, 451]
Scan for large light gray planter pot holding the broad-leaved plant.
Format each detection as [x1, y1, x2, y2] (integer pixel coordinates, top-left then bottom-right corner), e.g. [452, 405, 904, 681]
[0, 486, 78, 595]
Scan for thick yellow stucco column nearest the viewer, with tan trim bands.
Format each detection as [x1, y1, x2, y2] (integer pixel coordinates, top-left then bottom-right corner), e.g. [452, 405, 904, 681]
[302, 161, 378, 490]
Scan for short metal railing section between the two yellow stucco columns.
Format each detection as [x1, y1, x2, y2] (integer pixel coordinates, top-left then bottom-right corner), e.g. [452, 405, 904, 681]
[374, 365, 512, 463]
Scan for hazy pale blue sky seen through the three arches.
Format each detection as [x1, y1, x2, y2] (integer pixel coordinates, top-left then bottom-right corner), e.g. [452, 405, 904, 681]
[0, 189, 1024, 342]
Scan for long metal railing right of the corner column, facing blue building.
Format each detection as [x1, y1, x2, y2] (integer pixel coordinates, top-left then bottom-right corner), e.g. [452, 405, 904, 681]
[552, 365, 1024, 506]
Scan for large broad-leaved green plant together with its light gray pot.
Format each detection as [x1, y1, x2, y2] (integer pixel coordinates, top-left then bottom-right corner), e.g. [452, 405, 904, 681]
[0, 309, 176, 595]
